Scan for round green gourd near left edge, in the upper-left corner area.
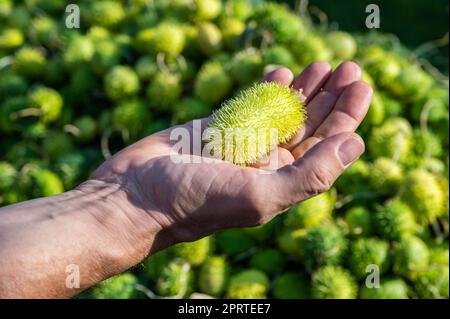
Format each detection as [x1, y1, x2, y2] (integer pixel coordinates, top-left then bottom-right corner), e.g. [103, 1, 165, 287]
[13, 47, 46, 78]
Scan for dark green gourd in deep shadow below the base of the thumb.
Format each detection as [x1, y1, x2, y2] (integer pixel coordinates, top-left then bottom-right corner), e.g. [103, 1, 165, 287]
[216, 229, 255, 256]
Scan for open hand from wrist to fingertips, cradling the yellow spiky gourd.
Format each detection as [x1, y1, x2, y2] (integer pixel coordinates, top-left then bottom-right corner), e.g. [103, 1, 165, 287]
[85, 62, 372, 262]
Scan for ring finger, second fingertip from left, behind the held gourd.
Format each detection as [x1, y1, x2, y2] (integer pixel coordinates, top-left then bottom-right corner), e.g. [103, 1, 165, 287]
[292, 62, 331, 102]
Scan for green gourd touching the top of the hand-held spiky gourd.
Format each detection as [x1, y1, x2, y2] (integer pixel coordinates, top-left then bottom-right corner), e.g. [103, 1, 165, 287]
[230, 48, 263, 86]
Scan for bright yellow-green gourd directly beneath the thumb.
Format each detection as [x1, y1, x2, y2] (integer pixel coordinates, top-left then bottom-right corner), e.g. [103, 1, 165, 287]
[284, 192, 335, 228]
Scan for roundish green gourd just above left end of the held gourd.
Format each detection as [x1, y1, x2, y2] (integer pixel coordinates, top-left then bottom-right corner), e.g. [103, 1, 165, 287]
[194, 62, 232, 106]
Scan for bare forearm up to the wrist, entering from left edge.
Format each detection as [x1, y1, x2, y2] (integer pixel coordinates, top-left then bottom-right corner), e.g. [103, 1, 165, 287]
[0, 181, 159, 298]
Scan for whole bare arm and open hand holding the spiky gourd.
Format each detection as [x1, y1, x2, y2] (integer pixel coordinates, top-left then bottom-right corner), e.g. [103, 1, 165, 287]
[0, 62, 372, 298]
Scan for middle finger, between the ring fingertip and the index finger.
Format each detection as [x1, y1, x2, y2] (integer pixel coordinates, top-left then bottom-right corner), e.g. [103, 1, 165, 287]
[284, 62, 361, 151]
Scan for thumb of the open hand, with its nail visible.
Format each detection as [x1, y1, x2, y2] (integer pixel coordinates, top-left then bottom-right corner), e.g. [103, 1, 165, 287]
[276, 133, 364, 204]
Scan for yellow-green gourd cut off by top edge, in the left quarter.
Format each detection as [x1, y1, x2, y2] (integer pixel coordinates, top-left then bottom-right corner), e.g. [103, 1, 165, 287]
[87, 0, 125, 29]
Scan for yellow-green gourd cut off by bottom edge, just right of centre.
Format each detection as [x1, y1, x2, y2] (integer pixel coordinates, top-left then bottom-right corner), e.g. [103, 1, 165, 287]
[226, 269, 269, 299]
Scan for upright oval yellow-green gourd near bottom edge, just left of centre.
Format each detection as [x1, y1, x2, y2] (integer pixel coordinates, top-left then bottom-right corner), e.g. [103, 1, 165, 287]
[198, 256, 230, 297]
